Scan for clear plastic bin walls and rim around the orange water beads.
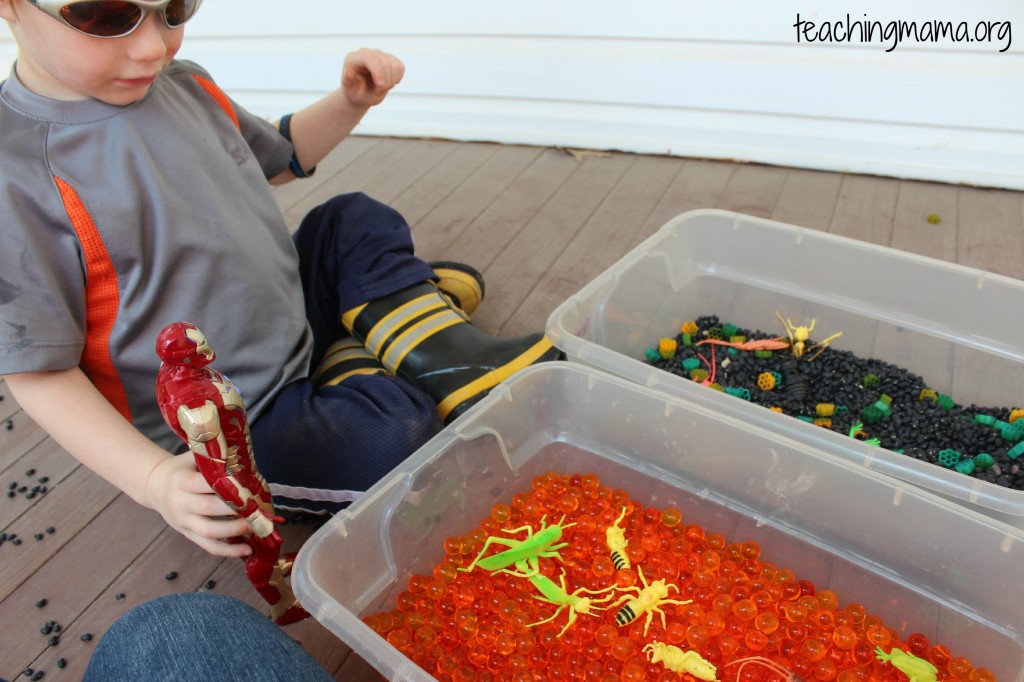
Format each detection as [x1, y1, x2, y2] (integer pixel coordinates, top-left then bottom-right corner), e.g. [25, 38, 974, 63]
[293, 363, 1024, 682]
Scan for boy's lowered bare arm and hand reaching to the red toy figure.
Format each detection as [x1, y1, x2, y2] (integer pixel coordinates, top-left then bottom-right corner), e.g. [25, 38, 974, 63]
[5, 368, 250, 556]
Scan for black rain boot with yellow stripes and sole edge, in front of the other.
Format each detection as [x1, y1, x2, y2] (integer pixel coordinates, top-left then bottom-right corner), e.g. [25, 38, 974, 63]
[341, 282, 562, 422]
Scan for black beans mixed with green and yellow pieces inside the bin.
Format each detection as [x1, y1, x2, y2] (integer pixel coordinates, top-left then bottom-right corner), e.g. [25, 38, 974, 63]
[647, 315, 1024, 491]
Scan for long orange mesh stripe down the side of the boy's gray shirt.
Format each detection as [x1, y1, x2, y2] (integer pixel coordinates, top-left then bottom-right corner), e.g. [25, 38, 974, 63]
[53, 177, 131, 421]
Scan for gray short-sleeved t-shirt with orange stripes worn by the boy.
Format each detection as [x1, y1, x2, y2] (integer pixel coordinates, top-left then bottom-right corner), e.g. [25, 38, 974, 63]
[0, 61, 311, 451]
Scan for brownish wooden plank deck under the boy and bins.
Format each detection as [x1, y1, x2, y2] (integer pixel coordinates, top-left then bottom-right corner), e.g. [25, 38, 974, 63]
[0, 137, 1024, 680]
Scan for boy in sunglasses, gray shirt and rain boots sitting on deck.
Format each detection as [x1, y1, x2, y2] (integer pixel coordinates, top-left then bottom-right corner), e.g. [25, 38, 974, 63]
[0, 0, 558, 556]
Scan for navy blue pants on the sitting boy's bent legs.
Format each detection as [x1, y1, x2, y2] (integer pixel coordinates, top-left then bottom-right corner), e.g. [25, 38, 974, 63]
[250, 194, 442, 512]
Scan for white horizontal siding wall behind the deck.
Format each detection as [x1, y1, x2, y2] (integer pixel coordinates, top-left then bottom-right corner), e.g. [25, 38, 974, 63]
[0, 0, 1024, 188]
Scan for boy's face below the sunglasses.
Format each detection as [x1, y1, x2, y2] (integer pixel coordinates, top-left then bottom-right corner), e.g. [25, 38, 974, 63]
[0, 0, 184, 105]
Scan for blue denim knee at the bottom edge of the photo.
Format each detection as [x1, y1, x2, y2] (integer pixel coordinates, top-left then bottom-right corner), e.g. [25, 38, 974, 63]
[83, 592, 334, 682]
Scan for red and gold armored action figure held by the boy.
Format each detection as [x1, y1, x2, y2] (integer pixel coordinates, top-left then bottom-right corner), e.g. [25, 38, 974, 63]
[157, 323, 308, 625]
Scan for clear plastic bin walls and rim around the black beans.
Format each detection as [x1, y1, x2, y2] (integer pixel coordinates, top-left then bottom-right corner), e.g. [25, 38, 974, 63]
[547, 210, 1024, 528]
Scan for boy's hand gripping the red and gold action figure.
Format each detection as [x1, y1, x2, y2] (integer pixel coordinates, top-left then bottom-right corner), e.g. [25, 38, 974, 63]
[146, 453, 251, 557]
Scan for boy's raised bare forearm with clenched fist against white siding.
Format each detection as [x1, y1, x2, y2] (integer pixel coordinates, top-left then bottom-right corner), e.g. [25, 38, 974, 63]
[270, 48, 406, 184]
